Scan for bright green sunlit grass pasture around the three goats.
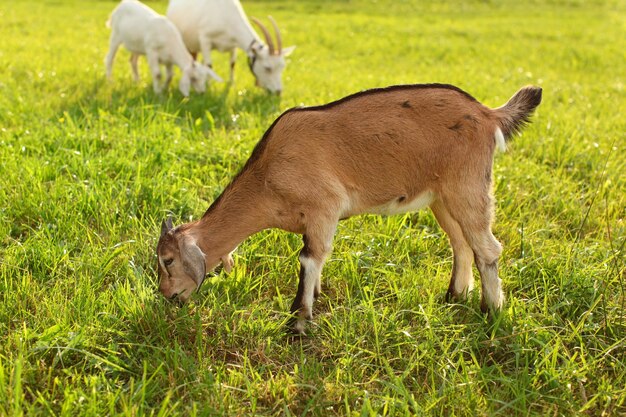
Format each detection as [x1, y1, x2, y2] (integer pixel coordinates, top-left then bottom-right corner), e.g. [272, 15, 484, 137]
[0, 0, 626, 416]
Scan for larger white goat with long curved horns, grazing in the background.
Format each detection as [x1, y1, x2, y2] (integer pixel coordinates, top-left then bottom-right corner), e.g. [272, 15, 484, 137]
[166, 0, 295, 94]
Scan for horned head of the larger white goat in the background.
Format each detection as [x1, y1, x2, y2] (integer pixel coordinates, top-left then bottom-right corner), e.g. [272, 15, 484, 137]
[248, 16, 296, 94]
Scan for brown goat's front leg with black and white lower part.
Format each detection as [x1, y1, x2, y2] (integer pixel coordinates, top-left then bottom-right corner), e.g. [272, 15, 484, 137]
[291, 222, 337, 334]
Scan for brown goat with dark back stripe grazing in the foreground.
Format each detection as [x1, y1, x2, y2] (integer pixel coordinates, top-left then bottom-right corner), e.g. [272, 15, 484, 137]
[157, 84, 541, 332]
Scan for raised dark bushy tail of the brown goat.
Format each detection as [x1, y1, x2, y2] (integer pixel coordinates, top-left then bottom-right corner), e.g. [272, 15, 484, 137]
[494, 86, 542, 139]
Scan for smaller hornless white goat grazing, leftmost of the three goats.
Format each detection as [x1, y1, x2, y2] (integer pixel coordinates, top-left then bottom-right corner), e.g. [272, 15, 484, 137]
[106, 0, 221, 97]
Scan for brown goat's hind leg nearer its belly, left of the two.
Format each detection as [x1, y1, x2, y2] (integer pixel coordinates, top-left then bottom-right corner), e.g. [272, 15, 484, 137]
[430, 200, 474, 301]
